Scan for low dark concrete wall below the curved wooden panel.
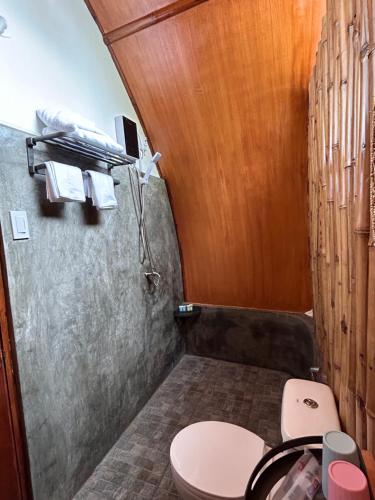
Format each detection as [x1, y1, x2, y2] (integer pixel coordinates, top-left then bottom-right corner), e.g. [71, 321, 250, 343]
[183, 306, 318, 378]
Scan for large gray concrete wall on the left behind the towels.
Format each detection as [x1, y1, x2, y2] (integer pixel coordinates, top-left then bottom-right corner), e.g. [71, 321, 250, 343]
[0, 126, 183, 500]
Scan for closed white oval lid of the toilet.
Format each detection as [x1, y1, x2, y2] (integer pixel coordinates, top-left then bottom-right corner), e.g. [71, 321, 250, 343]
[170, 421, 264, 499]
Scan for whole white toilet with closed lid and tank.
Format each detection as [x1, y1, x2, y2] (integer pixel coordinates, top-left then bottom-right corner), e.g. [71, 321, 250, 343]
[170, 379, 340, 500]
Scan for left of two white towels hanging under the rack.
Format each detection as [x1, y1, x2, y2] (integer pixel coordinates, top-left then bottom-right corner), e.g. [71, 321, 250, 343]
[46, 161, 86, 202]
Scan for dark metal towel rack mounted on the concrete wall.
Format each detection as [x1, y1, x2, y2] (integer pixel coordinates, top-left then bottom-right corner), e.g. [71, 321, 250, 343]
[26, 132, 136, 185]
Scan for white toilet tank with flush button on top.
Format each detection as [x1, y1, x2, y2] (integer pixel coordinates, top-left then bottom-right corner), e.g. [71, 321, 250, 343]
[281, 379, 341, 441]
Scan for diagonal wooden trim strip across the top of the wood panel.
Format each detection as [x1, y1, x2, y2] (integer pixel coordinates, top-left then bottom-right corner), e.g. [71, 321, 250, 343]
[100, 0, 208, 45]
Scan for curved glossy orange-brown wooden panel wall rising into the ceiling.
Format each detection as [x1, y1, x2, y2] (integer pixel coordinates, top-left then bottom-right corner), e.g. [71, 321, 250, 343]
[87, 0, 324, 311]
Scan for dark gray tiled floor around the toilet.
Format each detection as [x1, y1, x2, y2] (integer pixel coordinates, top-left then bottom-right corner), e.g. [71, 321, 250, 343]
[74, 355, 290, 500]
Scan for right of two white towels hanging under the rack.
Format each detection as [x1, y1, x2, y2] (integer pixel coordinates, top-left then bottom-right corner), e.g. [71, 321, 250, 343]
[85, 170, 117, 210]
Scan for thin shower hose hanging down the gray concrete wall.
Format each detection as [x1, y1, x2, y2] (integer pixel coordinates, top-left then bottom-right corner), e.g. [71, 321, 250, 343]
[128, 146, 161, 288]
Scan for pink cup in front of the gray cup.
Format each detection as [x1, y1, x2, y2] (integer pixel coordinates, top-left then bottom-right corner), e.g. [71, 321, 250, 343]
[328, 460, 370, 500]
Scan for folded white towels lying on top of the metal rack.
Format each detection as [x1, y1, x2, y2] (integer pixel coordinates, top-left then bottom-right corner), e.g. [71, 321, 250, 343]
[36, 108, 101, 134]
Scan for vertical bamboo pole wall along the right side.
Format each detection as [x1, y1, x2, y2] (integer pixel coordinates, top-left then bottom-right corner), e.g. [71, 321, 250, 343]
[309, 0, 375, 453]
